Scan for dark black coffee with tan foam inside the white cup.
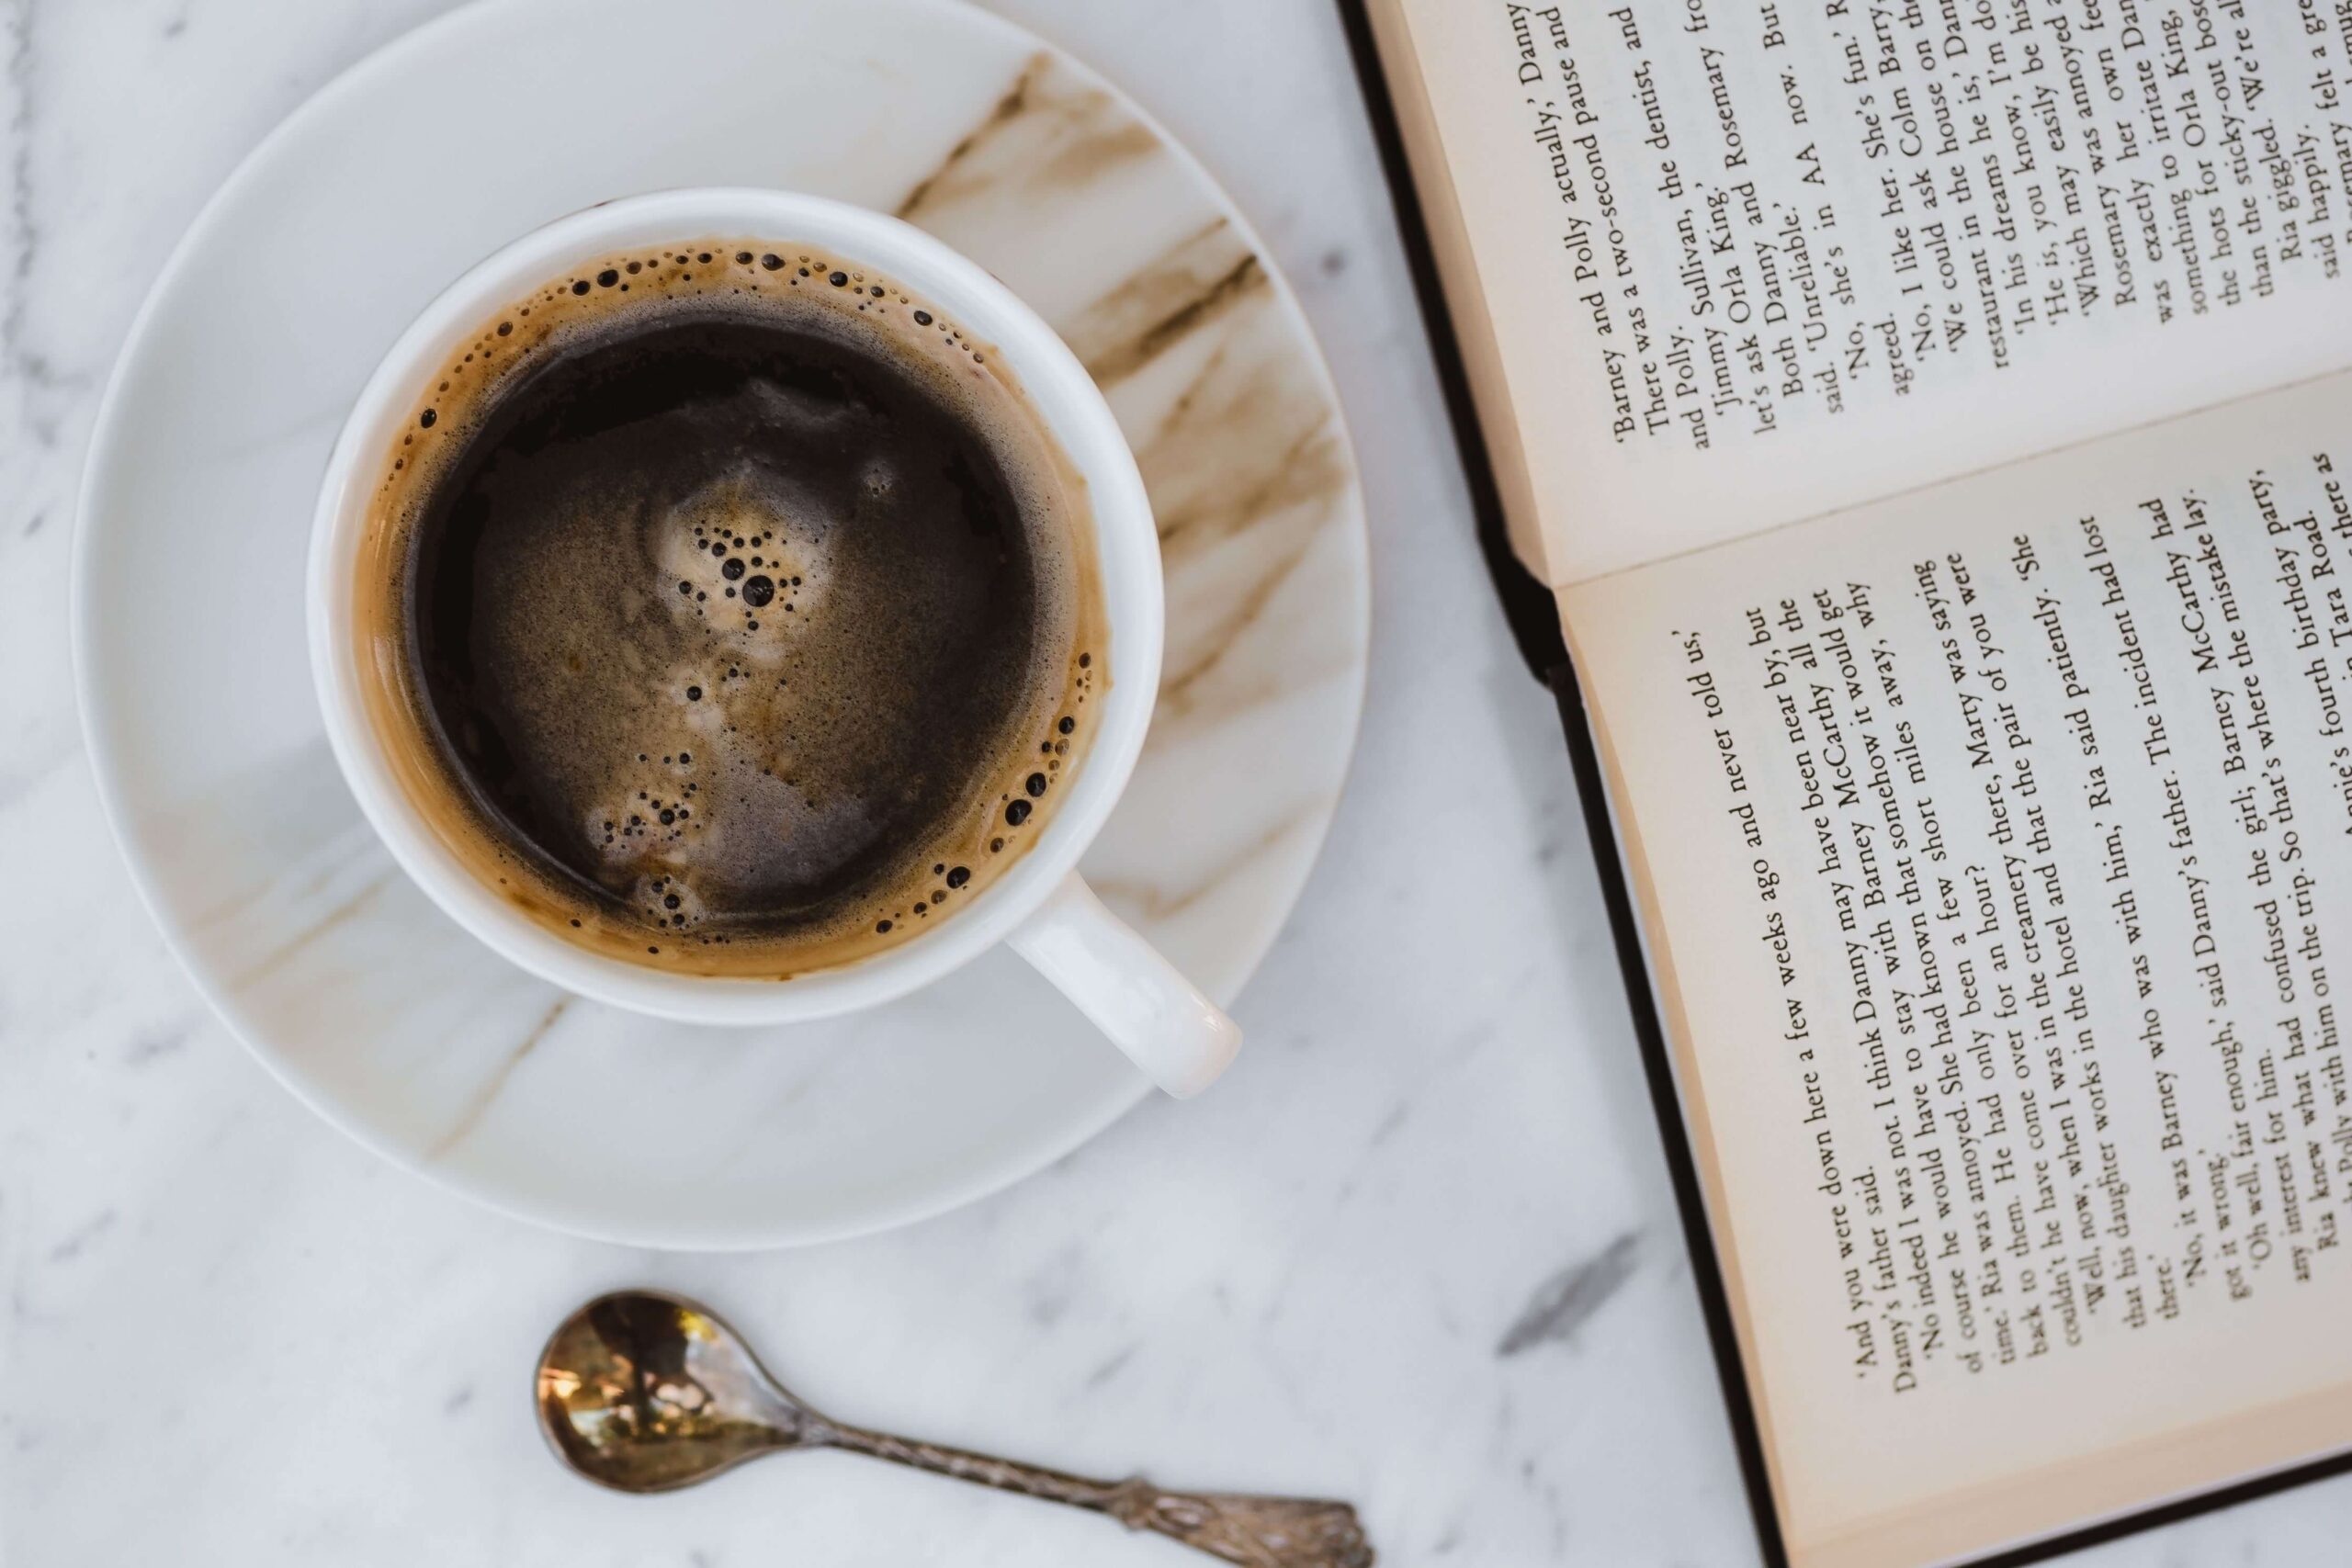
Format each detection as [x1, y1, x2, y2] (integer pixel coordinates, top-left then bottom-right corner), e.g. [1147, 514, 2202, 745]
[356, 237, 1108, 978]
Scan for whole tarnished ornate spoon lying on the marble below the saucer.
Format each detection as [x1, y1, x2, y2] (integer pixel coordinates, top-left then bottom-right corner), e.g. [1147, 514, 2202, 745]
[538, 1291, 1371, 1568]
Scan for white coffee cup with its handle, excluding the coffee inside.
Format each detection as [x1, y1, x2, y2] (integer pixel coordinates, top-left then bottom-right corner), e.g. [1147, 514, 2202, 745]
[308, 188, 1242, 1096]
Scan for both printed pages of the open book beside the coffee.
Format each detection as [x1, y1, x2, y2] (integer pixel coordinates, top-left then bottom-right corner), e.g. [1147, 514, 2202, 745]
[1366, 0, 2352, 1568]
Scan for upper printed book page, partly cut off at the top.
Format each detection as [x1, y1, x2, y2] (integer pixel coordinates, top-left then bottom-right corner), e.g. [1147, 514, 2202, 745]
[1374, 0, 2352, 585]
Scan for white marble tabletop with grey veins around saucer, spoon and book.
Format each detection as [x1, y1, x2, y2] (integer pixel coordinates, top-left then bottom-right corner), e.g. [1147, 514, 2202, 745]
[0, 0, 2352, 1568]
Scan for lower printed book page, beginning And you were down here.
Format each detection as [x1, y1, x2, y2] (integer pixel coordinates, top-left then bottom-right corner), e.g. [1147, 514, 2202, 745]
[1562, 376, 2352, 1568]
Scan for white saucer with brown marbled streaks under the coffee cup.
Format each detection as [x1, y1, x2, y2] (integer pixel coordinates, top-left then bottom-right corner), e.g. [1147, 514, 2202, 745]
[75, 0, 1369, 1248]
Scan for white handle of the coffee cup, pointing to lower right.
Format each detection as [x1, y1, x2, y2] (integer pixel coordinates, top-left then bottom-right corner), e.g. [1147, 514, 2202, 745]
[1007, 872, 1242, 1100]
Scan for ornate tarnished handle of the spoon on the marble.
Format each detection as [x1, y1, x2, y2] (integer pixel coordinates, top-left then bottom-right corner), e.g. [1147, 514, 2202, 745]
[826, 1422, 1371, 1568]
